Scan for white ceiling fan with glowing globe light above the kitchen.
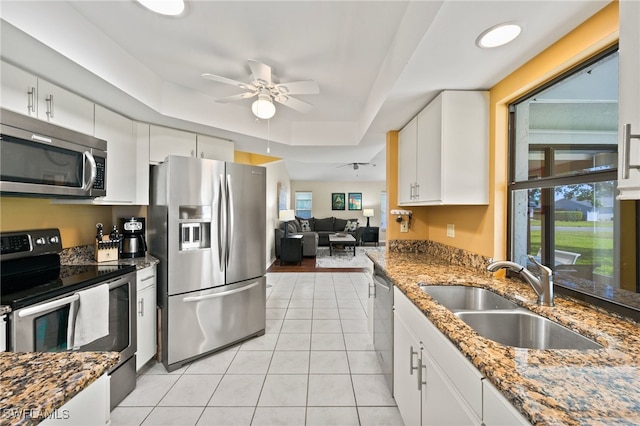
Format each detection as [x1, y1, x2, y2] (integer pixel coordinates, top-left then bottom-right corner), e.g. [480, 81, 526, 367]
[202, 59, 320, 119]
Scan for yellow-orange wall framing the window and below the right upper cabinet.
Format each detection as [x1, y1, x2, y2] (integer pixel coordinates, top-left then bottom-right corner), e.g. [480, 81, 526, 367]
[387, 2, 618, 259]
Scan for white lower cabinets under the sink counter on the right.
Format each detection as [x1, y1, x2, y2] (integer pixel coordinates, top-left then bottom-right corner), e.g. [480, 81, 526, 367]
[393, 288, 528, 426]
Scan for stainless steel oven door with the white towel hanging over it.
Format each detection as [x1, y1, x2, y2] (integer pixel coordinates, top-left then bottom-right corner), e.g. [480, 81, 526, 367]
[10, 273, 136, 360]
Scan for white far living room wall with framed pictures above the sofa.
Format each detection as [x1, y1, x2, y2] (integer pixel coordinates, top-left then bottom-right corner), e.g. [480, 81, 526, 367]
[290, 181, 386, 241]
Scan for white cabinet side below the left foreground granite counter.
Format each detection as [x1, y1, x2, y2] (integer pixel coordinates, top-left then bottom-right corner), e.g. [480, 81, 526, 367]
[40, 372, 111, 426]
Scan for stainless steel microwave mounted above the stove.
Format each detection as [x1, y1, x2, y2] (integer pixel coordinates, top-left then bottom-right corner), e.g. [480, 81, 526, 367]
[0, 118, 106, 197]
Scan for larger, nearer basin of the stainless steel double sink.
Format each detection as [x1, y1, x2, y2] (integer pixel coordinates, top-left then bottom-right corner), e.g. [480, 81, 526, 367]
[455, 309, 602, 350]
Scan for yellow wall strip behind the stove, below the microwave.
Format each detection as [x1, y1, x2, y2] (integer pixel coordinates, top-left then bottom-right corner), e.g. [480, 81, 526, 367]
[0, 197, 112, 248]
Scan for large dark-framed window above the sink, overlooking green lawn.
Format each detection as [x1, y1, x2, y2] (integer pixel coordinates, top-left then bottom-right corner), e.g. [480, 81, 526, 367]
[509, 50, 619, 285]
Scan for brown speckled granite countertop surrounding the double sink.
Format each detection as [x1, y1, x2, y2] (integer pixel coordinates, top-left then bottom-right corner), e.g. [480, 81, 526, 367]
[368, 251, 640, 425]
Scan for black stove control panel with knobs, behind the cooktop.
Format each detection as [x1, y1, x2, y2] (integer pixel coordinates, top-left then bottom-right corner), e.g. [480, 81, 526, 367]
[0, 229, 62, 260]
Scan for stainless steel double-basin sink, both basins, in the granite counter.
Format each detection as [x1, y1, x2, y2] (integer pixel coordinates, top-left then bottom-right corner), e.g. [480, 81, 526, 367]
[420, 285, 602, 350]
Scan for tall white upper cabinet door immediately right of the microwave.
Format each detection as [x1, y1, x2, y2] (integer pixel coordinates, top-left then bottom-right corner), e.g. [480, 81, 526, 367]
[95, 105, 137, 204]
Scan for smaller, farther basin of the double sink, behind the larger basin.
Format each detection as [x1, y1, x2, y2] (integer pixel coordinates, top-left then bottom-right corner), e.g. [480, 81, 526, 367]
[420, 285, 518, 312]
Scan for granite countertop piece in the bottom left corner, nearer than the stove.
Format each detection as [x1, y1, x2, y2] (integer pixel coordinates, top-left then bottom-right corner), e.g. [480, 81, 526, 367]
[0, 352, 120, 426]
